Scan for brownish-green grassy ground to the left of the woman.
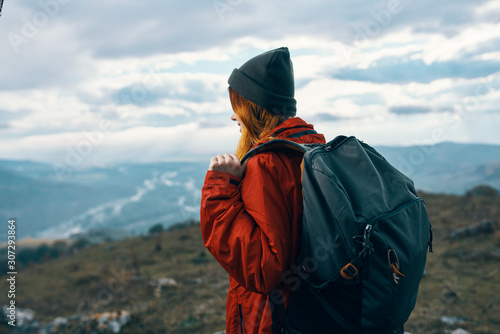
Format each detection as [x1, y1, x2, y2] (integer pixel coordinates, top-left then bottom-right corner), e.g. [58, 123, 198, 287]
[0, 226, 229, 333]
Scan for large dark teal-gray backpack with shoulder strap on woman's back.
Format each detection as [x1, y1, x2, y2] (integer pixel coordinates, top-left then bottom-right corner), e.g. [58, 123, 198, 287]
[242, 136, 432, 334]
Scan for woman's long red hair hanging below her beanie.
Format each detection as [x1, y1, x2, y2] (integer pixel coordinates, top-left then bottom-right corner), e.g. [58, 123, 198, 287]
[228, 87, 288, 159]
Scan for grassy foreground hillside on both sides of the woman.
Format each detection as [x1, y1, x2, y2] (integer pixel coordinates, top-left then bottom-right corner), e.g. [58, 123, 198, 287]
[0, 187, 500, 334]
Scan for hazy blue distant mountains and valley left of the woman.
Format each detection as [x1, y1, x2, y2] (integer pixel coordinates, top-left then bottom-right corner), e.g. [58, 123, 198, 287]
[0, 160, 207, 238]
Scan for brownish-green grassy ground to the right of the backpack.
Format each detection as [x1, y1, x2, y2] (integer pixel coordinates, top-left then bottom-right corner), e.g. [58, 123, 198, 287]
[405, 190, 500, 334]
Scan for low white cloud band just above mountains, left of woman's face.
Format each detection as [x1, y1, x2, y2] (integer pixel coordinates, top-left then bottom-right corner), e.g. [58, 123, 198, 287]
[0, 122, 239, 166]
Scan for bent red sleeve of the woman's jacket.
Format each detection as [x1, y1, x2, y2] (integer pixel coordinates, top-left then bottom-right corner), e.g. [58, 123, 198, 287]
[201, 154, 296, 293]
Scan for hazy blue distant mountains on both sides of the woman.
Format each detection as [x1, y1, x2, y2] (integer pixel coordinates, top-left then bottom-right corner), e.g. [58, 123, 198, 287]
[0, 143, 500, 240]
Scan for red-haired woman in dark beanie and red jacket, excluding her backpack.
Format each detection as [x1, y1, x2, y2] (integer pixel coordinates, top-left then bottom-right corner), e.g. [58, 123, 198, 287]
[201, 48, 325, 334]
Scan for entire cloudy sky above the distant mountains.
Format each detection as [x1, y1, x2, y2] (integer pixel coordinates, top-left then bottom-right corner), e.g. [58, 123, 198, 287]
[0, 0, 500, 168]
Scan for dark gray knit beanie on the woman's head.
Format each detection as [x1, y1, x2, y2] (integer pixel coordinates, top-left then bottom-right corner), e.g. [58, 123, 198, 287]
[228, 47, 297, 116]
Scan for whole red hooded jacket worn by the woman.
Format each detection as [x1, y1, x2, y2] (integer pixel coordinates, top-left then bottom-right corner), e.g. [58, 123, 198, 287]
[201, 117, 325, 334]
